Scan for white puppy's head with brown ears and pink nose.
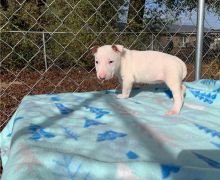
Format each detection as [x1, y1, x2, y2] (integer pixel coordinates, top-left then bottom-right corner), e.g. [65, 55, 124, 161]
[91, 45, 124, 80]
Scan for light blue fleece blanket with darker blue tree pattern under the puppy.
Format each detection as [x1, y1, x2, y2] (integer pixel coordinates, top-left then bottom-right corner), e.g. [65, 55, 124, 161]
[0, 80, 220, 180]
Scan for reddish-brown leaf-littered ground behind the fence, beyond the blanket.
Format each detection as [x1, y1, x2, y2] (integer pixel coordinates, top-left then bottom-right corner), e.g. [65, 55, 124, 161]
[0, 64, 217, 130]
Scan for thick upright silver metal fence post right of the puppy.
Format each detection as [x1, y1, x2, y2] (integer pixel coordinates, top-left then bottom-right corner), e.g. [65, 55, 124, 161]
[195, 0, 205, 80]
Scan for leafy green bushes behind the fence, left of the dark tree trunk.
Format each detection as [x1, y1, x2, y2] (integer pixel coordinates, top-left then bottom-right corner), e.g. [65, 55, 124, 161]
[0, 0, 127, 70]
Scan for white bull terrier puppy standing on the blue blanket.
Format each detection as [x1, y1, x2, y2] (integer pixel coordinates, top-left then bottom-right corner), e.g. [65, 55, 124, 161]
[91, 45, 187, 115]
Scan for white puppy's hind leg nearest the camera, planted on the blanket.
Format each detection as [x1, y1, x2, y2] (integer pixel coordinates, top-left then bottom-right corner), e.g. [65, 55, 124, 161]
[166, 78, 185, 115]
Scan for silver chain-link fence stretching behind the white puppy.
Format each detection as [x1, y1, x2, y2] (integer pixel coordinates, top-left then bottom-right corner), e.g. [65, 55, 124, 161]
[0, 0, 220, 128]
